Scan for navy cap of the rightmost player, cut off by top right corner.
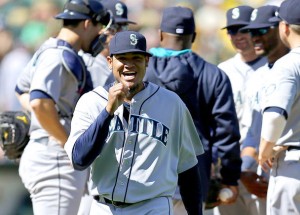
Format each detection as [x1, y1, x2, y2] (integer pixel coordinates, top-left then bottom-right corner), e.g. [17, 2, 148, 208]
[269, 0, 300, 25]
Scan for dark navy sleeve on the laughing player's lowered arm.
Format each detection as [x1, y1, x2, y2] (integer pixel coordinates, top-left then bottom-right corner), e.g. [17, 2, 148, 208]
[178, 165, 203, 215]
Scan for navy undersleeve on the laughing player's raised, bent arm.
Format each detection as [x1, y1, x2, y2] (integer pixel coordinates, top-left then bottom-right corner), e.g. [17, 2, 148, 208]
[72, 108, 113, 170]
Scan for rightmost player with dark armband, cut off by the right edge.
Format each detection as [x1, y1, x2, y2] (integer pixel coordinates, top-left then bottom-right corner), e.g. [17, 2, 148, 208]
[258, 0, 300, 215]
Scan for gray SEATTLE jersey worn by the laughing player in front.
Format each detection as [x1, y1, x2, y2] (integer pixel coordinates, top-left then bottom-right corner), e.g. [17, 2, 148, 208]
[65, 83, 203, 203]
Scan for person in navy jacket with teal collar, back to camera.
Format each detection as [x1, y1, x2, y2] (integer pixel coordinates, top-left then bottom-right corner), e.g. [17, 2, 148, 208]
[145, 7, 241, 214]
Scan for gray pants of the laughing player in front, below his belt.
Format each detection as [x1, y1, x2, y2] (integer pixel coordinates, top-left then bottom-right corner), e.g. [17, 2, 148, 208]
[90, 197, 173, 215]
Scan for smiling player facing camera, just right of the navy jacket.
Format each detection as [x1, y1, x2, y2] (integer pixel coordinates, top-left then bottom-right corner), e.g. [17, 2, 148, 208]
[218, 5, 266, 142]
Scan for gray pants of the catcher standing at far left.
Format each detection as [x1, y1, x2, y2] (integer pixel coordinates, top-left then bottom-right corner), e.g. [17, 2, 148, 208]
[19, 138, 87, 215]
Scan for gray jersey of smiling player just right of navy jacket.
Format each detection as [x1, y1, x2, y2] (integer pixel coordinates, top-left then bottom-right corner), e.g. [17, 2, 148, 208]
[218, 54, 266, 142]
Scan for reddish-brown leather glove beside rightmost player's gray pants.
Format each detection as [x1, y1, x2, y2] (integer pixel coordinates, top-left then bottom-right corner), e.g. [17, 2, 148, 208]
[240, 171, 268, 198]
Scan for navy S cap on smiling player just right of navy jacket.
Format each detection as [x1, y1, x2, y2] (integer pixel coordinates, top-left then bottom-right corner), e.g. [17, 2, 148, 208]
[222, 5, 253, 29]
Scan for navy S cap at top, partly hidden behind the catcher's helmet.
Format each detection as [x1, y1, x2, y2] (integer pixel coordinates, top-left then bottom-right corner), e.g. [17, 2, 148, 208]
[101, 0, 136, 24]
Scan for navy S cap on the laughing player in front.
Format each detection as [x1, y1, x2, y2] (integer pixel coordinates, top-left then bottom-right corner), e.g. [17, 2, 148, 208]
[109, 31, 152, 56]
